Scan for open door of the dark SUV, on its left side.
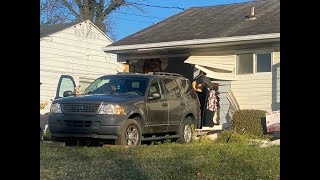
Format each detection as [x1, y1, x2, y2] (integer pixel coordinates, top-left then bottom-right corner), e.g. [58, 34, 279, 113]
[54, 75, 76, 99]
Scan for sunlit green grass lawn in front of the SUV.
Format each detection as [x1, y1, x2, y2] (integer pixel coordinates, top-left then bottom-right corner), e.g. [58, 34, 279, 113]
[40, 143, 280, 180]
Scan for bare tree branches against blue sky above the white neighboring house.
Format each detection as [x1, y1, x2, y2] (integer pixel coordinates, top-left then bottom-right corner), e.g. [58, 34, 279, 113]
[40, 0, 151, 36]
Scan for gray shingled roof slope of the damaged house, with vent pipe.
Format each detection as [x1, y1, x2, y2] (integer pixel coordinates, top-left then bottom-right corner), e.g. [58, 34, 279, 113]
[110, 0, 280, 46]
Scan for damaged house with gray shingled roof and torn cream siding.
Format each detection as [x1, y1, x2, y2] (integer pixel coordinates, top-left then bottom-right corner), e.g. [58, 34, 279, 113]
[104, 0, 280, 128]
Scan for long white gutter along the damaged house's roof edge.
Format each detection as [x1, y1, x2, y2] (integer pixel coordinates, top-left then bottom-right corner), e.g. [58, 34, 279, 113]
[103, 33, 280, 52]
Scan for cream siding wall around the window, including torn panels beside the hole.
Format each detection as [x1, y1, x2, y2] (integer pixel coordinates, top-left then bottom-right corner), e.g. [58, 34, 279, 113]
[185, 46, 280, 128]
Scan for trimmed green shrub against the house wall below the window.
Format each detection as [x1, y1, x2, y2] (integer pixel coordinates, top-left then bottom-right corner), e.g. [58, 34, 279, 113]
[231, 110, 266, 138]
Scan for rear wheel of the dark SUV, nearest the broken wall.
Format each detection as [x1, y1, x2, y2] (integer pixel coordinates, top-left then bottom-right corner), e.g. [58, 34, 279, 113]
[178, 117, 193, 144]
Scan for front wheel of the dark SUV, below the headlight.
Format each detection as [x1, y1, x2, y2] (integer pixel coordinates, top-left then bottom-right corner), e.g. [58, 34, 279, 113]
[115, 119, 141, 147]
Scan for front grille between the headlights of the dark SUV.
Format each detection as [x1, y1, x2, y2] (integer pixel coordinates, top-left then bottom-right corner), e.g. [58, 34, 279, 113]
[62, 103, 100, 113]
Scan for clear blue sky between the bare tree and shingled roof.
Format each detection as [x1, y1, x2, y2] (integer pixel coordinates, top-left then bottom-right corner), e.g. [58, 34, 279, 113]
[110, 0, 251, 41]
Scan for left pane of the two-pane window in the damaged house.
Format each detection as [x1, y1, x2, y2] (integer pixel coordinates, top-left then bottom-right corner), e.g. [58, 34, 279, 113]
[237, 54, 253, 74]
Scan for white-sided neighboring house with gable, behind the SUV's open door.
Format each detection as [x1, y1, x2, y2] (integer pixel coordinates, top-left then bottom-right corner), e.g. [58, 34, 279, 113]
[40, 20, 123, 112]
